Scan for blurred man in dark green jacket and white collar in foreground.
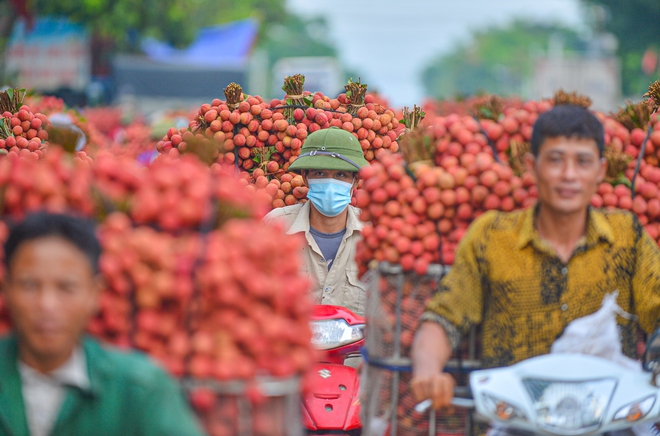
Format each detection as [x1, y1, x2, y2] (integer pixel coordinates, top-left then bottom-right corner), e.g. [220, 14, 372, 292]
[0, 209, 202, 436]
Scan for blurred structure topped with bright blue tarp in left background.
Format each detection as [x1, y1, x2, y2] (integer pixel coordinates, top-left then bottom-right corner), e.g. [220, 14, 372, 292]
[112, 19, 259, 113]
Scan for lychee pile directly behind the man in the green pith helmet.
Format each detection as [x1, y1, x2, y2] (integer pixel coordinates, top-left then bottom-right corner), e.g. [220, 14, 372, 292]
[158, 75, 403, 207]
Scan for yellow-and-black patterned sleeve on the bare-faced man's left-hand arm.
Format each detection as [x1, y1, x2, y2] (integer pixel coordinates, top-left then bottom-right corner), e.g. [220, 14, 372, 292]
[427, 213, 495, 332]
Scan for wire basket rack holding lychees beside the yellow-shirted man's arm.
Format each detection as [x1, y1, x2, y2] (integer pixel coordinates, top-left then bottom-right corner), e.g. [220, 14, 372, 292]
[362, 262, 481, 436]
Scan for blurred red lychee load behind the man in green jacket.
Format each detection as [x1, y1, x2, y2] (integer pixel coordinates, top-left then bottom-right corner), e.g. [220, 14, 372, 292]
[0, 135, 313, 435]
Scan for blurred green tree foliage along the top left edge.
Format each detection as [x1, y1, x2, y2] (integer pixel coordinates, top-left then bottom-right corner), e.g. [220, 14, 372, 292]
[0, 0, 337, 82]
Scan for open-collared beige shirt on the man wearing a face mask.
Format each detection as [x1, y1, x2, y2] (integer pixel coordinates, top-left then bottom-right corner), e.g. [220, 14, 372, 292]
[264, 201, 366, 315]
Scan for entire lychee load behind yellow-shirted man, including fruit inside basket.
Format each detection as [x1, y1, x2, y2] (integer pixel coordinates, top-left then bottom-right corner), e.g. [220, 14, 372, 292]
[356, 83, 660, 434]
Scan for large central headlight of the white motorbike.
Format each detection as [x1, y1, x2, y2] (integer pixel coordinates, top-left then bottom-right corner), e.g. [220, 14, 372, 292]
[523, 379, 616, 433]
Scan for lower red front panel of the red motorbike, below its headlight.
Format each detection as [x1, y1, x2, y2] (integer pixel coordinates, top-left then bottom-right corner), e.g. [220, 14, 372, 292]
[303, 363, 360, 431]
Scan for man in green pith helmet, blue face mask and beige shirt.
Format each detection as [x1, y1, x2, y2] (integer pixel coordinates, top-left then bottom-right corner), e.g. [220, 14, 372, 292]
[265, 127, 369, 315]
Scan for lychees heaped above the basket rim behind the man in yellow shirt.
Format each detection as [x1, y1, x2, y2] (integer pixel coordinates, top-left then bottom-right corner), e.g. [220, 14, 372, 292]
[357, 86, 660, 274]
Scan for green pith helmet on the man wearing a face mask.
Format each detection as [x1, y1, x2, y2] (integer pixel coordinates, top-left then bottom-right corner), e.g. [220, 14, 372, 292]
[289, 127, 369, 172]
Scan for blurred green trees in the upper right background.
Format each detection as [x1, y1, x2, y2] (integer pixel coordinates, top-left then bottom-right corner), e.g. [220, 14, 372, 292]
[422, 0, 660, 98]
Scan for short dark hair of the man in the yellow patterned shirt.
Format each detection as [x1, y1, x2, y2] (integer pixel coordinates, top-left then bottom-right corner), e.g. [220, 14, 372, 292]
[531, 104, 605, 157]
